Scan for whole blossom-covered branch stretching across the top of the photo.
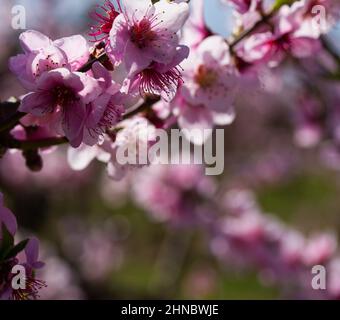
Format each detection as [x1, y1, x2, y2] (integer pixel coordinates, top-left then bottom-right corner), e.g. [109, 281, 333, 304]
[0, 0, 339, 172]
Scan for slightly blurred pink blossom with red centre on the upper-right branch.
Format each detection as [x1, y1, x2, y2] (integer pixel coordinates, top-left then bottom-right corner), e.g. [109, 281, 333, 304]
[238, 2, 320, 66]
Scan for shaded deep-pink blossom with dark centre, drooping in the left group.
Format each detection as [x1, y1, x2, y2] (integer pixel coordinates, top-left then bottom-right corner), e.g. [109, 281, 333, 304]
[19, 68, 102, 147]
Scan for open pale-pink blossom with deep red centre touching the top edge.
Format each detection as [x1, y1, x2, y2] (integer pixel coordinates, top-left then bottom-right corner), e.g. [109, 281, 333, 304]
[110, 0, 189, 75]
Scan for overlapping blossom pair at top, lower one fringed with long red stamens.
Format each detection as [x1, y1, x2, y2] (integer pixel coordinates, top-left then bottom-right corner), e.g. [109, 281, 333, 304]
[107, 0, 189, 96]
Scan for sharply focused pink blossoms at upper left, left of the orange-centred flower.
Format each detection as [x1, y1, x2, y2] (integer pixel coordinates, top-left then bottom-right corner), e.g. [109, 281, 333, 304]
[4, 0, 194, 172]
